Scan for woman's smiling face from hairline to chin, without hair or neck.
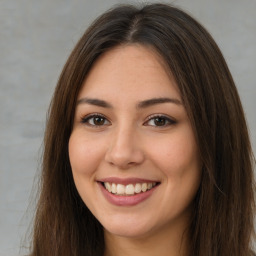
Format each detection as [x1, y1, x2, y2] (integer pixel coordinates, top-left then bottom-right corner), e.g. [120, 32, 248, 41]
[69, 45, 201, 237]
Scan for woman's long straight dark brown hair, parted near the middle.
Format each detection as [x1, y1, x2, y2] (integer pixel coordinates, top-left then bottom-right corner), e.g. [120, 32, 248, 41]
[31, 4, 254, 256]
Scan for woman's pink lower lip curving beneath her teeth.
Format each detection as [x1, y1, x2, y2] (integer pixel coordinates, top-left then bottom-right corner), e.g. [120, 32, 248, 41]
[99, 183, 158, 206]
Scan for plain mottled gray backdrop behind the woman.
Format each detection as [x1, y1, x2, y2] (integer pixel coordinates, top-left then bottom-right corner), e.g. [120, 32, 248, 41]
[0, 0, 256, 256]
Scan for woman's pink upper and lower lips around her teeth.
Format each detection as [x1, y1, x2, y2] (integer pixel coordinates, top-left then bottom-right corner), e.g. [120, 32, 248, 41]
[98, 177, 158, 206]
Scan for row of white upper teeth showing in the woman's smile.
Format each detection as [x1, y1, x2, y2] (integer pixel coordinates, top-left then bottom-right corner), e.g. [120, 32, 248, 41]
[104, 182, 156, 195]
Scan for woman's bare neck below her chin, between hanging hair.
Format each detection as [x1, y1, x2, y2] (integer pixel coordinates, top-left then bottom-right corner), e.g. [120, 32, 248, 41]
[104, 219, 189, 256]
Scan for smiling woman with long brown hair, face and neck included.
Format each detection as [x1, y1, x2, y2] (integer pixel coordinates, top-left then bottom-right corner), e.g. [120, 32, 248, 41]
[31, 4, 254, 256]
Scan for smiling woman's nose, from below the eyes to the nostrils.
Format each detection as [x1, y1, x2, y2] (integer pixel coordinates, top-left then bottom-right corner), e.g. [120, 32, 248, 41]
[105, 126, 144, 169]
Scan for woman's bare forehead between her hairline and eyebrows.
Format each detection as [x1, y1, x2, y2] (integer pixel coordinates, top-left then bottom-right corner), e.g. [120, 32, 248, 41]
[79, 44, 179, 101]
